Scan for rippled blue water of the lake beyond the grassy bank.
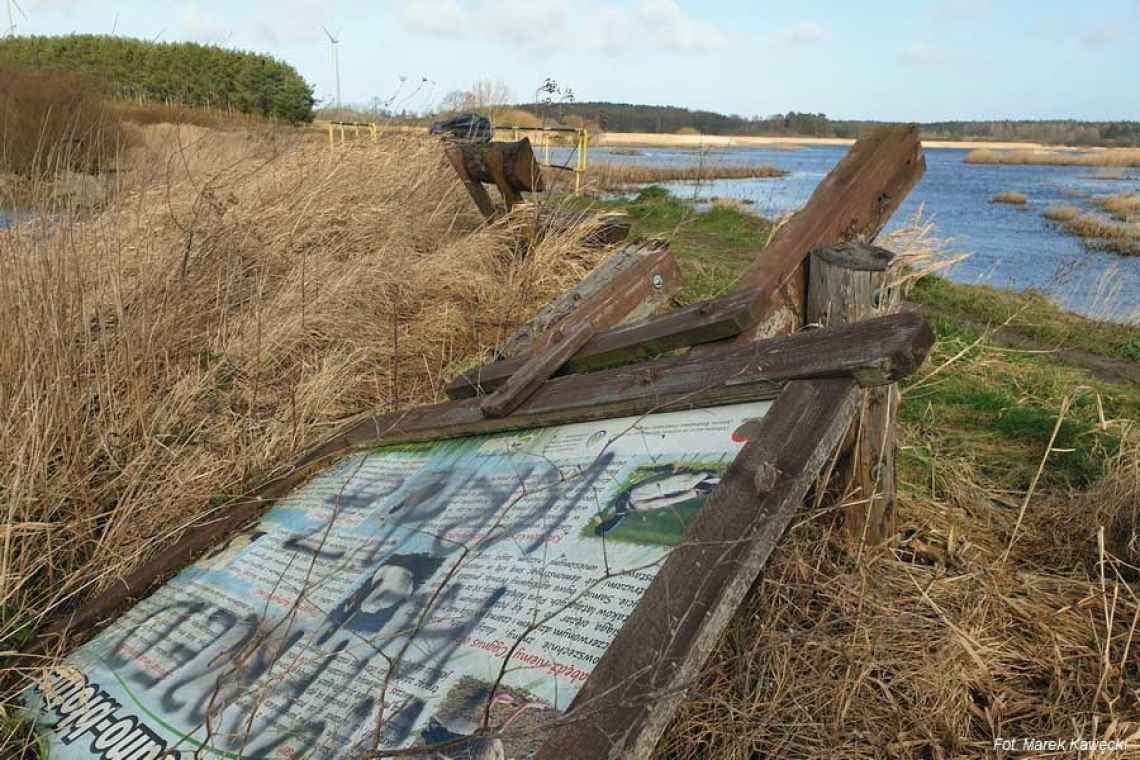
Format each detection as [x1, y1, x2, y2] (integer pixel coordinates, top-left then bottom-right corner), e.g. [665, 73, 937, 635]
[551, 146, 1140, 324]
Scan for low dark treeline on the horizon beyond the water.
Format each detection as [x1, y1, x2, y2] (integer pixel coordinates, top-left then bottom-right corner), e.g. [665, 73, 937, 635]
[519, 103, 1140, 146]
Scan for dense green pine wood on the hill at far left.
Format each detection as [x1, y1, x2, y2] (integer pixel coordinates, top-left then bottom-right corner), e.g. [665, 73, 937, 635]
[0, 34, 315, 124]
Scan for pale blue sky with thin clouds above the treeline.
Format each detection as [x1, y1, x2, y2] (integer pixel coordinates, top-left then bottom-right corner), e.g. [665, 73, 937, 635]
[8, 0, 1140, 121]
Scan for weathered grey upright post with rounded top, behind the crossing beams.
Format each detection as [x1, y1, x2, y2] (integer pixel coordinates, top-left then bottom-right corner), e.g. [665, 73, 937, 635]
[807, 244, 898, 548]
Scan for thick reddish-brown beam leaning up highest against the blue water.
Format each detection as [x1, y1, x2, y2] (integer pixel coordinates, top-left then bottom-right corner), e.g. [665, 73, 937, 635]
[736, 125, 926, 341]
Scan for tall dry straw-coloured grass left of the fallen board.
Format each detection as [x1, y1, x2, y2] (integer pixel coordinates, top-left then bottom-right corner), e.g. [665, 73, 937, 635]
[0, 126, 604, 706]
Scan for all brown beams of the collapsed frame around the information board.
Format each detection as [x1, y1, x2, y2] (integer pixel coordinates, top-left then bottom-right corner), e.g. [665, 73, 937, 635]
[29, 128, 934, 760]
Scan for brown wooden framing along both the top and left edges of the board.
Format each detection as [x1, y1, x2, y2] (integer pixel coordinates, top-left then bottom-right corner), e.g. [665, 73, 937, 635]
[39, 314, 934, 649]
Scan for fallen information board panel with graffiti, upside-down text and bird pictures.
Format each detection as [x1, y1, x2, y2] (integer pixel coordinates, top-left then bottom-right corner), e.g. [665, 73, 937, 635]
[29, 401, 771, 760]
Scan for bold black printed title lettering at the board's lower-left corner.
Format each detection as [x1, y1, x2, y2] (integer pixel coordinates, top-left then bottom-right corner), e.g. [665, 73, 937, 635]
[40, 671, 166, 760]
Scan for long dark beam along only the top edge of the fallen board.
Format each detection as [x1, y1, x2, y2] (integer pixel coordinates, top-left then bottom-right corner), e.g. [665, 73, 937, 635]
[325, 314, 934, 451]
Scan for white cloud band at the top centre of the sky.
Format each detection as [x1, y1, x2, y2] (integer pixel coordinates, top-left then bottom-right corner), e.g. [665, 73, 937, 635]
[399, 0, 727, 54]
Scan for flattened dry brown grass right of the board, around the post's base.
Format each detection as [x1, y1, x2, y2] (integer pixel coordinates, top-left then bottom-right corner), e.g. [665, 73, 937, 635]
[662, 282, 1140, 760]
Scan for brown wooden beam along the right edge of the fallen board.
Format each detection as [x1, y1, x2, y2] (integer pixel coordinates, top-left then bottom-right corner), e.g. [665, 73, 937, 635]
[538, 378, 855, 760]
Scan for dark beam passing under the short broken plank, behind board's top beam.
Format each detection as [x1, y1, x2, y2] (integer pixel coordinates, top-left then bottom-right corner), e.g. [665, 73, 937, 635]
[447, 293, 758, 399]
